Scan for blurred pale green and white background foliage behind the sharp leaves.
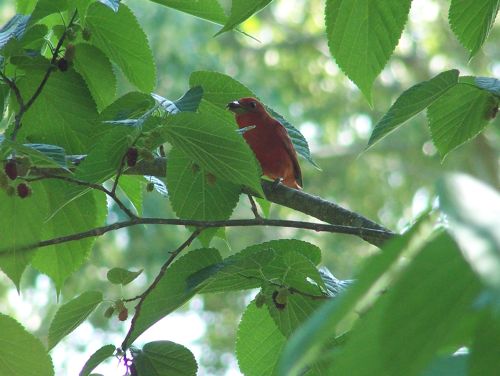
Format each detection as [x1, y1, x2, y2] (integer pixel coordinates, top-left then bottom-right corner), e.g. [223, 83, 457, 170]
[0, 0, 500, 374]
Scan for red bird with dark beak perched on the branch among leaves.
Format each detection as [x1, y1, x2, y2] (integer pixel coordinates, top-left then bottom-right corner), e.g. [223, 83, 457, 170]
[227, 98, 302, 189]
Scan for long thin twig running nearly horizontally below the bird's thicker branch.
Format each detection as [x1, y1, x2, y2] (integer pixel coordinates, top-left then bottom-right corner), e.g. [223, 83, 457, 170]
[0, 217, 397, 254]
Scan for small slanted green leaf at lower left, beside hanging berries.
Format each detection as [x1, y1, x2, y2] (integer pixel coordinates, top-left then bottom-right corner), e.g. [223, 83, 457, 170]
[48, 291, 102, 349]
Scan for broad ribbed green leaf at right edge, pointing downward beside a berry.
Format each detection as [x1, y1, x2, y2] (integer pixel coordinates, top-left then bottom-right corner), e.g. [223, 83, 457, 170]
[427, 84, 499, 160]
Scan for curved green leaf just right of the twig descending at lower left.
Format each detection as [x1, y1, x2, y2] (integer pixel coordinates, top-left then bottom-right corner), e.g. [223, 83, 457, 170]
[123, 248, 221, 347]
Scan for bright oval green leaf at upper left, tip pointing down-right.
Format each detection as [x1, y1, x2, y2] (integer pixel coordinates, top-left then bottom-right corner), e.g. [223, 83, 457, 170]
[86, 3, 156, 92]
